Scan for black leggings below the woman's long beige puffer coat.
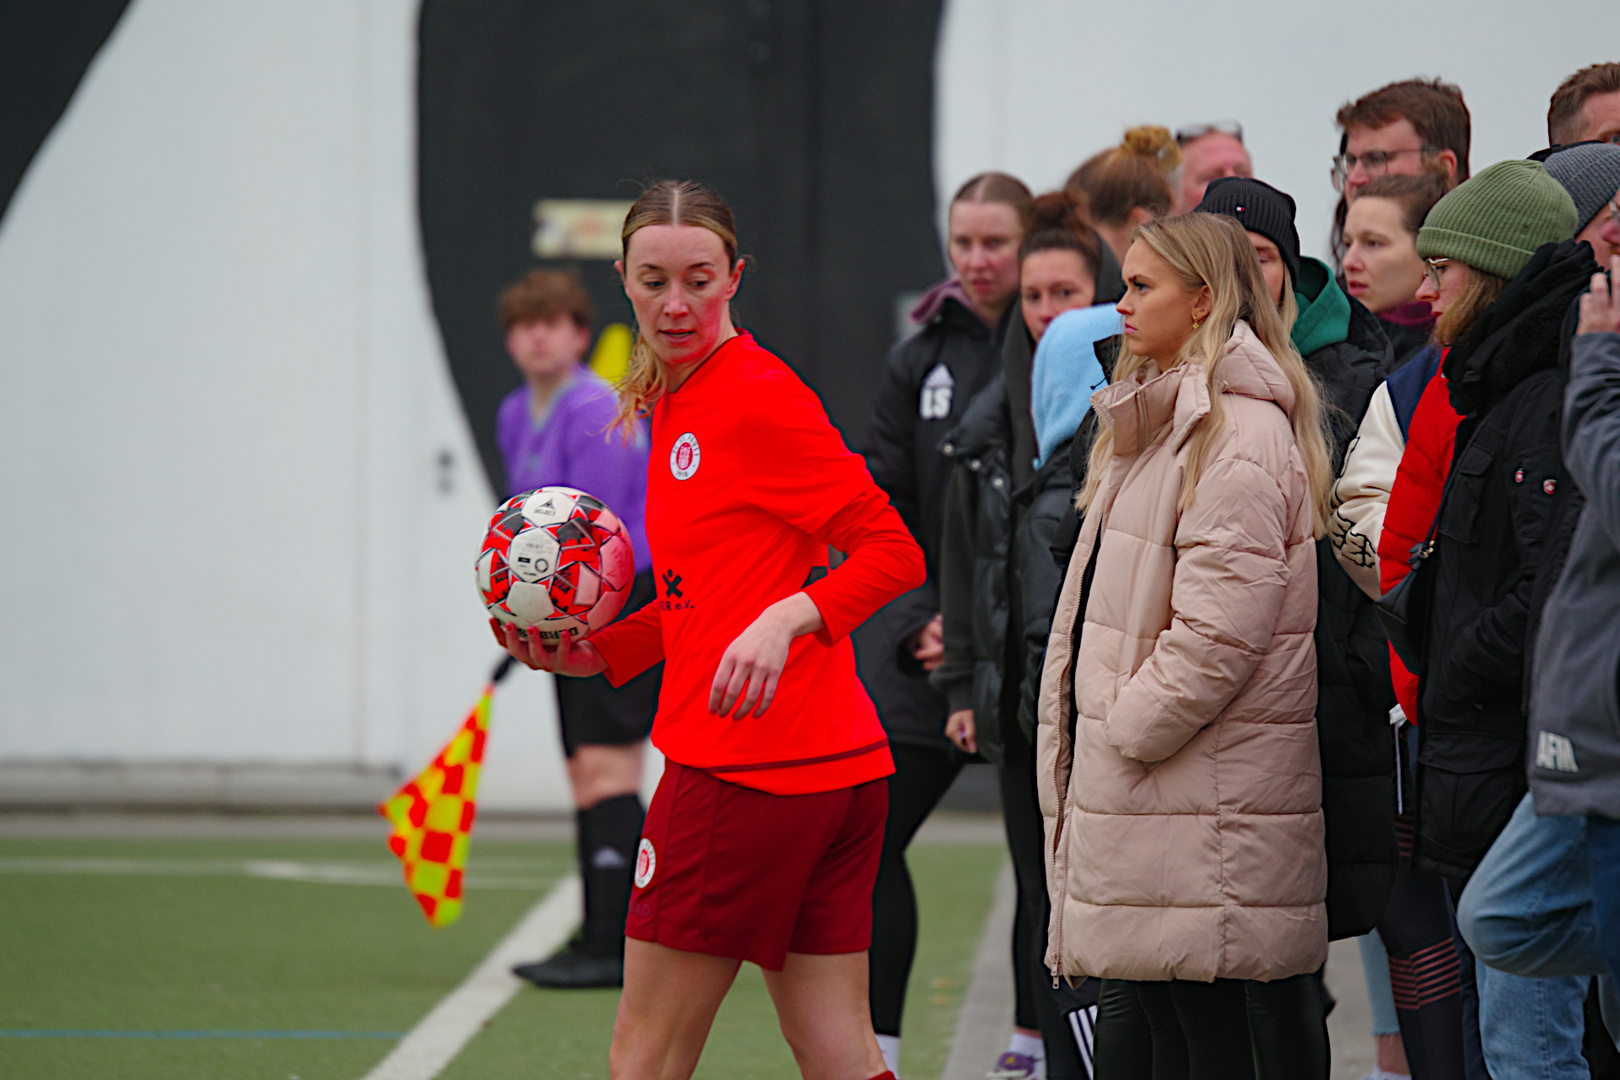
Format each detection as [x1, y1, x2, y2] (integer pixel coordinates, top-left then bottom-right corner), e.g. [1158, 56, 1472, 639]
[1092, 978, 1254, 1080]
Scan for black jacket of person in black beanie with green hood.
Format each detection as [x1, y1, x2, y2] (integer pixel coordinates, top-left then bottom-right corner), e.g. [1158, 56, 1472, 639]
[1306, 298, 1398, 939]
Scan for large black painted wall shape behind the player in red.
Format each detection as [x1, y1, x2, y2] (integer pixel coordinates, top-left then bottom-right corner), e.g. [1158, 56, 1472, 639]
[418, 0, 943, 487]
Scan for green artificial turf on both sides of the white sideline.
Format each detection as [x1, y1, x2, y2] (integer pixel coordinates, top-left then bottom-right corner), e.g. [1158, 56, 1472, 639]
[0, 839, 1004, 1080]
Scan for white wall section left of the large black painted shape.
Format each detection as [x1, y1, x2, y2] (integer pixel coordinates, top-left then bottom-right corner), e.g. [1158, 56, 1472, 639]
[0, 0, 567, 808]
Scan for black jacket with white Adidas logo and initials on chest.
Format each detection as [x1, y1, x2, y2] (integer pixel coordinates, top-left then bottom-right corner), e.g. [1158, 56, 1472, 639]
[855, 282, 1016, 750]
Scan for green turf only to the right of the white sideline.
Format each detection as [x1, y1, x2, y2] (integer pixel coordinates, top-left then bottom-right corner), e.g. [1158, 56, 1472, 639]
[442, 845, 1006, 1080]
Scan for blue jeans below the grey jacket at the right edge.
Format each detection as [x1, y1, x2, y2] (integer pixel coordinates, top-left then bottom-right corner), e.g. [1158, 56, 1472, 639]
[1456, 795, 1620, 1080]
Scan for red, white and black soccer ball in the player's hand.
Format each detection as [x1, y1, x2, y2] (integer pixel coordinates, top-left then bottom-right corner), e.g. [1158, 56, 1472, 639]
[476, 487, 635, 641]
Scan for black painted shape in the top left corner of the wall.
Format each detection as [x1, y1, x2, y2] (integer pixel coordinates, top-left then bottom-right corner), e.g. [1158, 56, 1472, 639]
[0, 0, 130, 226]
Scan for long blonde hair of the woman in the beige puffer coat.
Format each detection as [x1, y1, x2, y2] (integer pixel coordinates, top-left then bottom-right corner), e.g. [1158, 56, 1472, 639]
[1076, 214, 1333, 538]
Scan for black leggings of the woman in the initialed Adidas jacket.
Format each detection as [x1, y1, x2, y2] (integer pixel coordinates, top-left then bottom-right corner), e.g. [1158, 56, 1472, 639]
[867, 743, 967, 1036]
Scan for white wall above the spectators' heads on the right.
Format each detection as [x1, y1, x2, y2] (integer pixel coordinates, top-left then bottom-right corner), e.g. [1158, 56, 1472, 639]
[935, 0, 1620, 254]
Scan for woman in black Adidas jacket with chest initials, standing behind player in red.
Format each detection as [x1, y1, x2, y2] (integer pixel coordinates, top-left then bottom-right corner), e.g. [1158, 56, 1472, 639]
[855, 173, 1030, 1070]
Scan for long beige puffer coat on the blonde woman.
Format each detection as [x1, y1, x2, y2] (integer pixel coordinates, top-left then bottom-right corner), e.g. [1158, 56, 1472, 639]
[1035, 322, 1327, 981]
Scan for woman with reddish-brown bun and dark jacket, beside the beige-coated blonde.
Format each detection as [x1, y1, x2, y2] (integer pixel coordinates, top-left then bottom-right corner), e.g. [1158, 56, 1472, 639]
[933, 191, 1118, 1080]
